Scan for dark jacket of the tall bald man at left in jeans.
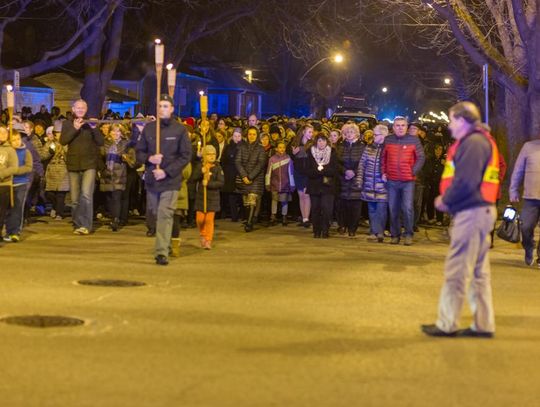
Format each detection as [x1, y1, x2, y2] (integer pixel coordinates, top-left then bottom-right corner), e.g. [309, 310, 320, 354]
[60, 120, 104, 171]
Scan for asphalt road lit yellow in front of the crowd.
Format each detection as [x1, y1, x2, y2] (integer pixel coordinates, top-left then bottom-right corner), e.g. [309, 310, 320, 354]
[0, 221, 540, 407]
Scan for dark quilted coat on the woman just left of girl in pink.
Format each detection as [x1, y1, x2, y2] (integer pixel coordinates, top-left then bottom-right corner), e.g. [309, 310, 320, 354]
[235, 141, 267, 195]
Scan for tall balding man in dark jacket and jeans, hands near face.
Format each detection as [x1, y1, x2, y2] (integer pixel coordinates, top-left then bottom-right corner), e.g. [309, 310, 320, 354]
[60, 99, 104, 235]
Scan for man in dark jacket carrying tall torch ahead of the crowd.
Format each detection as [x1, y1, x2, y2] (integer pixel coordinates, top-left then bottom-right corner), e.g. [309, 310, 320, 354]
[136, 94, 191, 266]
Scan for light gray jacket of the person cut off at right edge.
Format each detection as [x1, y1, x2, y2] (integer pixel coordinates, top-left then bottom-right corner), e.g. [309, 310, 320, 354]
[510, 140, 540, 199]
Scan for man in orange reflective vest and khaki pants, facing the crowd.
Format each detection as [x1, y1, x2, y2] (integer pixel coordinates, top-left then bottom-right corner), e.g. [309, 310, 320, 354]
[422, 102, 500, 338]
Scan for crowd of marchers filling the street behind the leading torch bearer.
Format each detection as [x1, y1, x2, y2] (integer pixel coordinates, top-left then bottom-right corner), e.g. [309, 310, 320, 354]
[0, 104, 540, 264]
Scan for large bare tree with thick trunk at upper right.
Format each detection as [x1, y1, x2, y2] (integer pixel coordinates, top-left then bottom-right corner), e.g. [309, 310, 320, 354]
[363, 0, 540, 159]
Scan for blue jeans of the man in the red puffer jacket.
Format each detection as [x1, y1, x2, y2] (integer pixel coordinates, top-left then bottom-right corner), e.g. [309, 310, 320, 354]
[386, 181, 414, 237]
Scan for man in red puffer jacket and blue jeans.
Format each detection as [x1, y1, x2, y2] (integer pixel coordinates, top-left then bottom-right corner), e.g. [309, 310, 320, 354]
[382, 116, 425, 246]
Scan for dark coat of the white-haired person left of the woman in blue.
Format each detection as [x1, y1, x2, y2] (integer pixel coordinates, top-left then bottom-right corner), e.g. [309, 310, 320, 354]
[336, 140, 365, 199]
